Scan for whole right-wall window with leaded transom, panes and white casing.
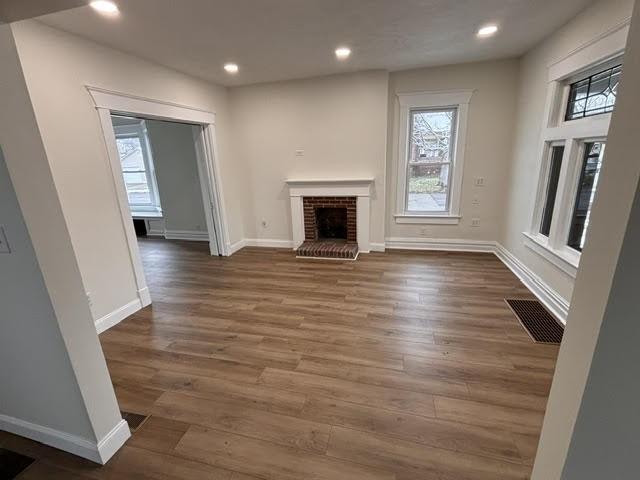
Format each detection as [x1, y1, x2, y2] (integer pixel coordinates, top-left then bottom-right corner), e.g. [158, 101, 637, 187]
[525, 54, 622, 277]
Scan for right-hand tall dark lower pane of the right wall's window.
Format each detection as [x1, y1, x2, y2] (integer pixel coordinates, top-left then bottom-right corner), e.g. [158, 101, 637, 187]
[567, 142, 605, 252]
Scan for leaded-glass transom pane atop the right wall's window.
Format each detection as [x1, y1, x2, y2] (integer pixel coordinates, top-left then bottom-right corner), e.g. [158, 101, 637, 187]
[565, 65, 622, 121]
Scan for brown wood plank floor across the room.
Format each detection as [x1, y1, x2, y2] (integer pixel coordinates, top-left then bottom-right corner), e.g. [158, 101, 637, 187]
[0, 240, 558, 480]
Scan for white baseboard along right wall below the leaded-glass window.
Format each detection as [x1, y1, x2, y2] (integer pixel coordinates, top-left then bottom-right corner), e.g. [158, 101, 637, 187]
[495, 243, 569, 325]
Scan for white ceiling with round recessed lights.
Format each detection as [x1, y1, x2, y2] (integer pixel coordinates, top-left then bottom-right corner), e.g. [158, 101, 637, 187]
[40, 0, 592, 85]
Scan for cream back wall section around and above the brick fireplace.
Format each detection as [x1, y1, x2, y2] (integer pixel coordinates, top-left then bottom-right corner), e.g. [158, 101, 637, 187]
[230, 71, 387, 248]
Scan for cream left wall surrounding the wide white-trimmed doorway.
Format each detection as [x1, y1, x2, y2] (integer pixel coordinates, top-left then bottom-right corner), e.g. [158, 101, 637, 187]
[8, 21, 247, 319]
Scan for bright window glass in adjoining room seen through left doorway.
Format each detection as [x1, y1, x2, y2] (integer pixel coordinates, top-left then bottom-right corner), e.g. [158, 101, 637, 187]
[116, 137, 153, 205]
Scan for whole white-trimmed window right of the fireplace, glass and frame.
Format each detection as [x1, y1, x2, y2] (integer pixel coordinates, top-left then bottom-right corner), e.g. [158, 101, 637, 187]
[394, 91, 472, 224]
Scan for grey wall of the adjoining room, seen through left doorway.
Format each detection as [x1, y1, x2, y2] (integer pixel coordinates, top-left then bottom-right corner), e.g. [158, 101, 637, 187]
[145, 120, 207, 234]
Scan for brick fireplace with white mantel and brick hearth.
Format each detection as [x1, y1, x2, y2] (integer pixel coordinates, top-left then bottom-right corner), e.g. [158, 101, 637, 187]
[286, 179, 373, 259]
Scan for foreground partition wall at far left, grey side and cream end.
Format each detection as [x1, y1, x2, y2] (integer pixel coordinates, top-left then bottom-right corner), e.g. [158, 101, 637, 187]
[0, 25, 129, 461]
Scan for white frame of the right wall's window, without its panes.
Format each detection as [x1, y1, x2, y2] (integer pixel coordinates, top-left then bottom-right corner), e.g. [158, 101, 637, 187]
[523, 24, 628, 278]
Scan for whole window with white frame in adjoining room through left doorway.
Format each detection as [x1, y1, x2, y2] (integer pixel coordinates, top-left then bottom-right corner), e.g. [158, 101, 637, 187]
[114, 121, 161, 212]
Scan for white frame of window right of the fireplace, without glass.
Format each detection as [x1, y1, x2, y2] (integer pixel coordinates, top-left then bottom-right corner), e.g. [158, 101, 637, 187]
[394, 90, 473, 224]
